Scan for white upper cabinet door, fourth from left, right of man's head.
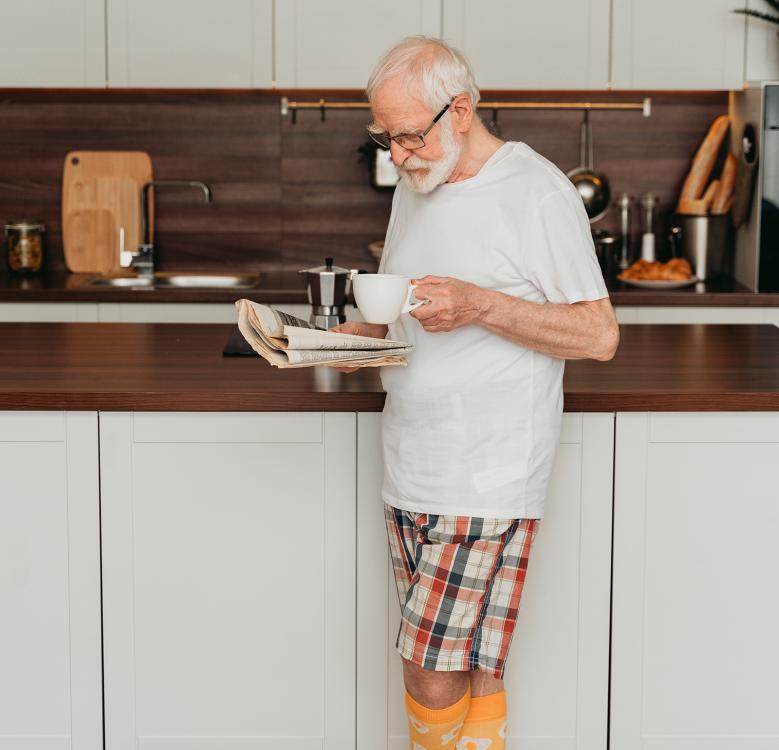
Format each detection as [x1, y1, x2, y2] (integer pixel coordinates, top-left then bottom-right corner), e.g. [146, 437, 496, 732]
[443, 0, 609, 89]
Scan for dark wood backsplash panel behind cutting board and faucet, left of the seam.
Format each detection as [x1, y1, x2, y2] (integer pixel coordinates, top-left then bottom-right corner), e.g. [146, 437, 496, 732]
[0, 91, 281, 270]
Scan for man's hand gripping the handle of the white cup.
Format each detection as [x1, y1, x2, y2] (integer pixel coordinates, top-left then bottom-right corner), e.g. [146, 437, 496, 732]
[410, 276, 485, 333]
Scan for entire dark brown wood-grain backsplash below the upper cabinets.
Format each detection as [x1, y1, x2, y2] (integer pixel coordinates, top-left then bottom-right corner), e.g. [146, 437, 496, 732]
[0, 90, 727, 276]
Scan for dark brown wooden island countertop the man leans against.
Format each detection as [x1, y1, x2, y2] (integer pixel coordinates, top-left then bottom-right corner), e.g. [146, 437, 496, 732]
[0, 323, 779, 411]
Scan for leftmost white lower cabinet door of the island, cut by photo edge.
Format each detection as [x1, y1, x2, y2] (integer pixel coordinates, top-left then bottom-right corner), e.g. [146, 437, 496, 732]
[0, 412, 103, 750]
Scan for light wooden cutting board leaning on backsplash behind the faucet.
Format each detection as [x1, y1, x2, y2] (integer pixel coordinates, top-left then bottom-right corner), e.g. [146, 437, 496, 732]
[62, 151, 154, 274]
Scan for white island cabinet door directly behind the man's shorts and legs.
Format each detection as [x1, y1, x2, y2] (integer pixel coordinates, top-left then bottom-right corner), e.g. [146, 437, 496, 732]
[357, 414, 614, 750]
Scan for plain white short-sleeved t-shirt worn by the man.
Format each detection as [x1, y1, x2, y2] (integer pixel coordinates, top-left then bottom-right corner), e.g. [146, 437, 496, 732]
[380, 143, 608, 518]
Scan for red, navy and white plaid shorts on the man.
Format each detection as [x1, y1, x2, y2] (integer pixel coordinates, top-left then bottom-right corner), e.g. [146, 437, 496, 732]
[384, 503, 540, 679]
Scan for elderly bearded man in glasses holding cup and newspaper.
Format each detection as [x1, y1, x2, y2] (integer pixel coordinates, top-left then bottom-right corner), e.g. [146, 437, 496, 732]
[337, 37, 619, 750]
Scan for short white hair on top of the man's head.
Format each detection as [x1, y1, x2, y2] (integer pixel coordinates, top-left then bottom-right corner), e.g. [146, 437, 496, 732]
[366, 35, 480, 110]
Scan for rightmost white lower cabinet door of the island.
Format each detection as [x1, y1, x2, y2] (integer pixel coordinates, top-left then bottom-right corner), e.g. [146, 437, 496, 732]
[610, 413, 779, 750]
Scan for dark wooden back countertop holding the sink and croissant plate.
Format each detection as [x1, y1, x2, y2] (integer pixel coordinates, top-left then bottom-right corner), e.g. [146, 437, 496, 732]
[0, 269, 779, 307]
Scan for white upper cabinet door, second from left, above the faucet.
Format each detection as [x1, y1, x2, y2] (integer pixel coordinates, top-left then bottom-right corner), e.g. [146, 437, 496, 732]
[107, 0, 273, 88]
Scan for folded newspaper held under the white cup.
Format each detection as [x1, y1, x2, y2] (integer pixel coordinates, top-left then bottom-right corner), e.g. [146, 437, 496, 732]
[235, 299, 414, 367]
